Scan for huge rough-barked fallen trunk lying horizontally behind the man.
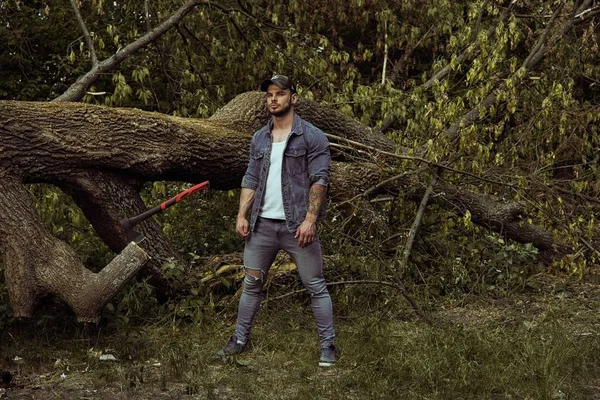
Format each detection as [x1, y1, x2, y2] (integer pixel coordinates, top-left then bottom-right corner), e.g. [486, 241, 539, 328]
[0, 92, 554, 256]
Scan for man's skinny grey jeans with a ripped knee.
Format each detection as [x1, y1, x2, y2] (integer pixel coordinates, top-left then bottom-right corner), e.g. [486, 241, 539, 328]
[235, 217, 335, 348]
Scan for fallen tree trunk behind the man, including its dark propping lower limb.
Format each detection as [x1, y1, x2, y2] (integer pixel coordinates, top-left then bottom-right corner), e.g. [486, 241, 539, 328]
[0, 92, 564, 257]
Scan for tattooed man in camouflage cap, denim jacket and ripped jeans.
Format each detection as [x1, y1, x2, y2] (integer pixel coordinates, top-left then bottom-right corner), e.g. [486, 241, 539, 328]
[217, 75, 336, 367]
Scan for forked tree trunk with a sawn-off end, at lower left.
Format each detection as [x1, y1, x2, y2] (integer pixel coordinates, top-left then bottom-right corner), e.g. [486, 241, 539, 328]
[0, 170, 148, 322]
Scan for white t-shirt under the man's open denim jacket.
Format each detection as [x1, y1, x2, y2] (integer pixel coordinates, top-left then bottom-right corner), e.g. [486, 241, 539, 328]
[259, 141, 287, 219]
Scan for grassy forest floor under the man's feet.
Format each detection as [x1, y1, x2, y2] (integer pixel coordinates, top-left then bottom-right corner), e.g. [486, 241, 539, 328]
[0, 270, 600, 400]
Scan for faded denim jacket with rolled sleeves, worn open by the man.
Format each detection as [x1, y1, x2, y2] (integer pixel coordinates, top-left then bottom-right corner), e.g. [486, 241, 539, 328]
[242, 114, 331, 233]
